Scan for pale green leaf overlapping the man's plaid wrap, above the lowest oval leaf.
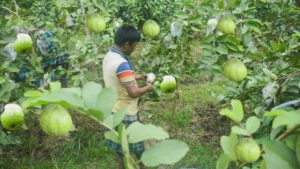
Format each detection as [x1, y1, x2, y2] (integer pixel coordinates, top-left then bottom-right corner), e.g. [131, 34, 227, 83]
[127, 122, 169, 143]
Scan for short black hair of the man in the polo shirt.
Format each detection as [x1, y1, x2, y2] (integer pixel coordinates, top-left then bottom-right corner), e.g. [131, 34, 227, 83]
[114, 25, 141, 46]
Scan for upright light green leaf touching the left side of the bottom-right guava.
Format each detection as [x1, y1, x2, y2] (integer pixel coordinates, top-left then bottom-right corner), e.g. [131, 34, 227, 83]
[221, 133, 238, 160]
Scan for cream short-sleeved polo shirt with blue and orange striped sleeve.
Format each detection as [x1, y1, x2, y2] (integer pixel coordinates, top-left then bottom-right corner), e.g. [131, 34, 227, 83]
[102, 48, 138, 116]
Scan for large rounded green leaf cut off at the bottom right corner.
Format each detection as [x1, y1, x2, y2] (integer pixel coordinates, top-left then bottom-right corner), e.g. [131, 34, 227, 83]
[263, 141, 300, 169]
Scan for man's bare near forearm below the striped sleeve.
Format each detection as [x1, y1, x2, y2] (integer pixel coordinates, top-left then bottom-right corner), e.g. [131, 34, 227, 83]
[125, 83, 153, 98]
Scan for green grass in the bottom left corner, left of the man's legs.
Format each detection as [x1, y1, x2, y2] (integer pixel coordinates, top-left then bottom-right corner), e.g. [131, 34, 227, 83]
[0, 129, 117, 169]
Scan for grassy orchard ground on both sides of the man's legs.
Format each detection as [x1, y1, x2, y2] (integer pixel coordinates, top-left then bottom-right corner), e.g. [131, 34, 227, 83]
[0, 77, 230, 169]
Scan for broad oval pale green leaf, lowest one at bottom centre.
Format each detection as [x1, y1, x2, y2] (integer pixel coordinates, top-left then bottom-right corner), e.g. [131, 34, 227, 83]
[141, 140, 189, 167]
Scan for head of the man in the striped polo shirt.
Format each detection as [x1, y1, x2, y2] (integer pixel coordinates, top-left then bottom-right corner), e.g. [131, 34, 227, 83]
[114, 25, 141, 55]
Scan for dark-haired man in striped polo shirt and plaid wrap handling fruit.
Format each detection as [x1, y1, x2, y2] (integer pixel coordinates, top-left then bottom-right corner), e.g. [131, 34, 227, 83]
[102, 25, 155, 169]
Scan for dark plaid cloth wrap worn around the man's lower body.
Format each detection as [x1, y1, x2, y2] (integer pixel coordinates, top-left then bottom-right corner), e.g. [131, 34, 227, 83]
[104, 115, 145, 158]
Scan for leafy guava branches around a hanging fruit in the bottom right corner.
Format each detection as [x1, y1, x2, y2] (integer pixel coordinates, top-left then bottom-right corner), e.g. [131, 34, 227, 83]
[217, 100, 300, 169]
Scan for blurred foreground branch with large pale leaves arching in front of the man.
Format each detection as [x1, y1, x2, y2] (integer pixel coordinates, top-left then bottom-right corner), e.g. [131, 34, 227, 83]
[22, 82, 189, 168]
